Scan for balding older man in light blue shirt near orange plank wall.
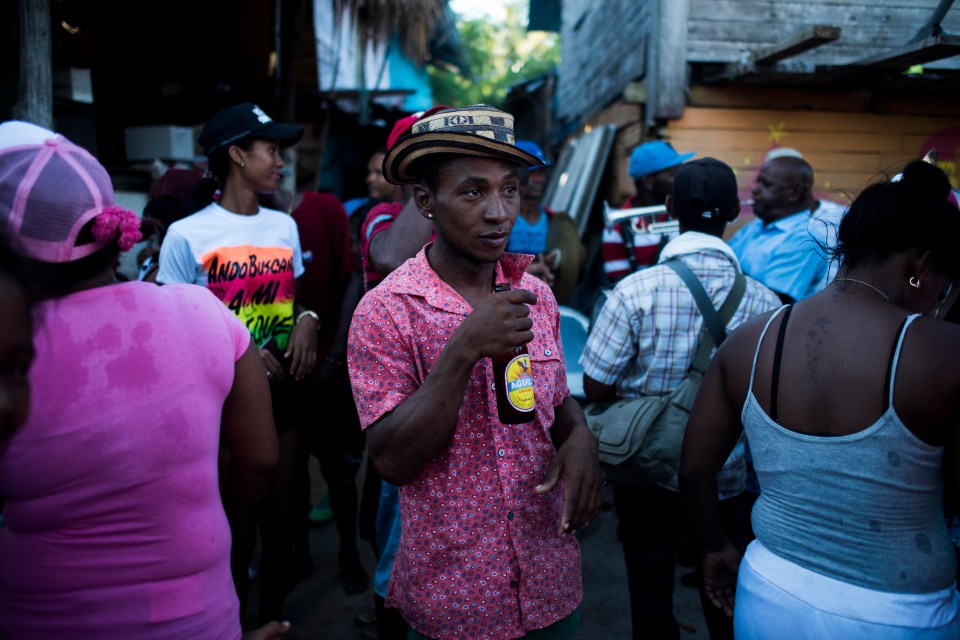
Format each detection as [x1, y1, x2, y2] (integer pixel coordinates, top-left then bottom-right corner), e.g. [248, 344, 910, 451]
[730, 156, 828, 302]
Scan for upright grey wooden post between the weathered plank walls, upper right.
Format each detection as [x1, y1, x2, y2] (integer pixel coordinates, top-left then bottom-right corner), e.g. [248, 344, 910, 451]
[646, 0, 690, 126]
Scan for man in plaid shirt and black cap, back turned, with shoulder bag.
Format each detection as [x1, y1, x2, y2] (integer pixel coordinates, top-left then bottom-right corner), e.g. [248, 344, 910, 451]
[580, 158, 780, 640]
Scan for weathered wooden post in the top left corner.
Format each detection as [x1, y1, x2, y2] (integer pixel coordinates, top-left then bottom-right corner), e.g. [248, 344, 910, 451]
[13, 0, 54, 130]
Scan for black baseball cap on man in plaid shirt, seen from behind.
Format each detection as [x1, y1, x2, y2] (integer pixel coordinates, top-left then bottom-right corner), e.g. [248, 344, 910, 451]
[672, 158, 740, 219]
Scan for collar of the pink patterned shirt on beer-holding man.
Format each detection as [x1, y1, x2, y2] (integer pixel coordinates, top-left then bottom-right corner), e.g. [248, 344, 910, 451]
[390, 242, 533, 314]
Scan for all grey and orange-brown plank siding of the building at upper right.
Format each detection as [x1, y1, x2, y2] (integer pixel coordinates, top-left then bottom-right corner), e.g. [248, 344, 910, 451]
[558, 0, 960, 239]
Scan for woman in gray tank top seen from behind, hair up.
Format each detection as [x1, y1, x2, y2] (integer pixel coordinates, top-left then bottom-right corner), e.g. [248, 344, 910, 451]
[680, 161, 960, 639]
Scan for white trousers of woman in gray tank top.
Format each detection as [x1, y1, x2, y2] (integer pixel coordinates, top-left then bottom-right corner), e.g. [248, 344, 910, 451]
[733, 540, 960, 640]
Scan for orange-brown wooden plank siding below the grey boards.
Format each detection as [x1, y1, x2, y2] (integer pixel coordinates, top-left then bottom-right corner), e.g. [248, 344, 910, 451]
[662, 107, 960, 222]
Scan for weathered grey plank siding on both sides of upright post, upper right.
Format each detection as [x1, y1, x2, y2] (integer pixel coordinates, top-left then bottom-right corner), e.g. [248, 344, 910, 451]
[557, 0, 960, 122]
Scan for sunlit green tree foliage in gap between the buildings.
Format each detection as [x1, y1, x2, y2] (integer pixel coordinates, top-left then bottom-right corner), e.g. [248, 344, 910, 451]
[429, 0, 560, 107]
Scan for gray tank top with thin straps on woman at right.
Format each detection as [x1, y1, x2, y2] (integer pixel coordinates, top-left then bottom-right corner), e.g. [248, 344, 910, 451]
[741, 307, 956, 593]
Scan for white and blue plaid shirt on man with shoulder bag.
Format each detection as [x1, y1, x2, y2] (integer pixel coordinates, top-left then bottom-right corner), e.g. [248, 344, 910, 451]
[580, 231, 781, 499]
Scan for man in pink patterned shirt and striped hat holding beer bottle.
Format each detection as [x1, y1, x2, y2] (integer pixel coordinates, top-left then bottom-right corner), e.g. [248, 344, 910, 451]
[349, 105, 600, 640]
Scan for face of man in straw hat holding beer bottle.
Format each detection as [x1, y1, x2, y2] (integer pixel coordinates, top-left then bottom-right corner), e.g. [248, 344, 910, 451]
[414, 157, 520, 264]
